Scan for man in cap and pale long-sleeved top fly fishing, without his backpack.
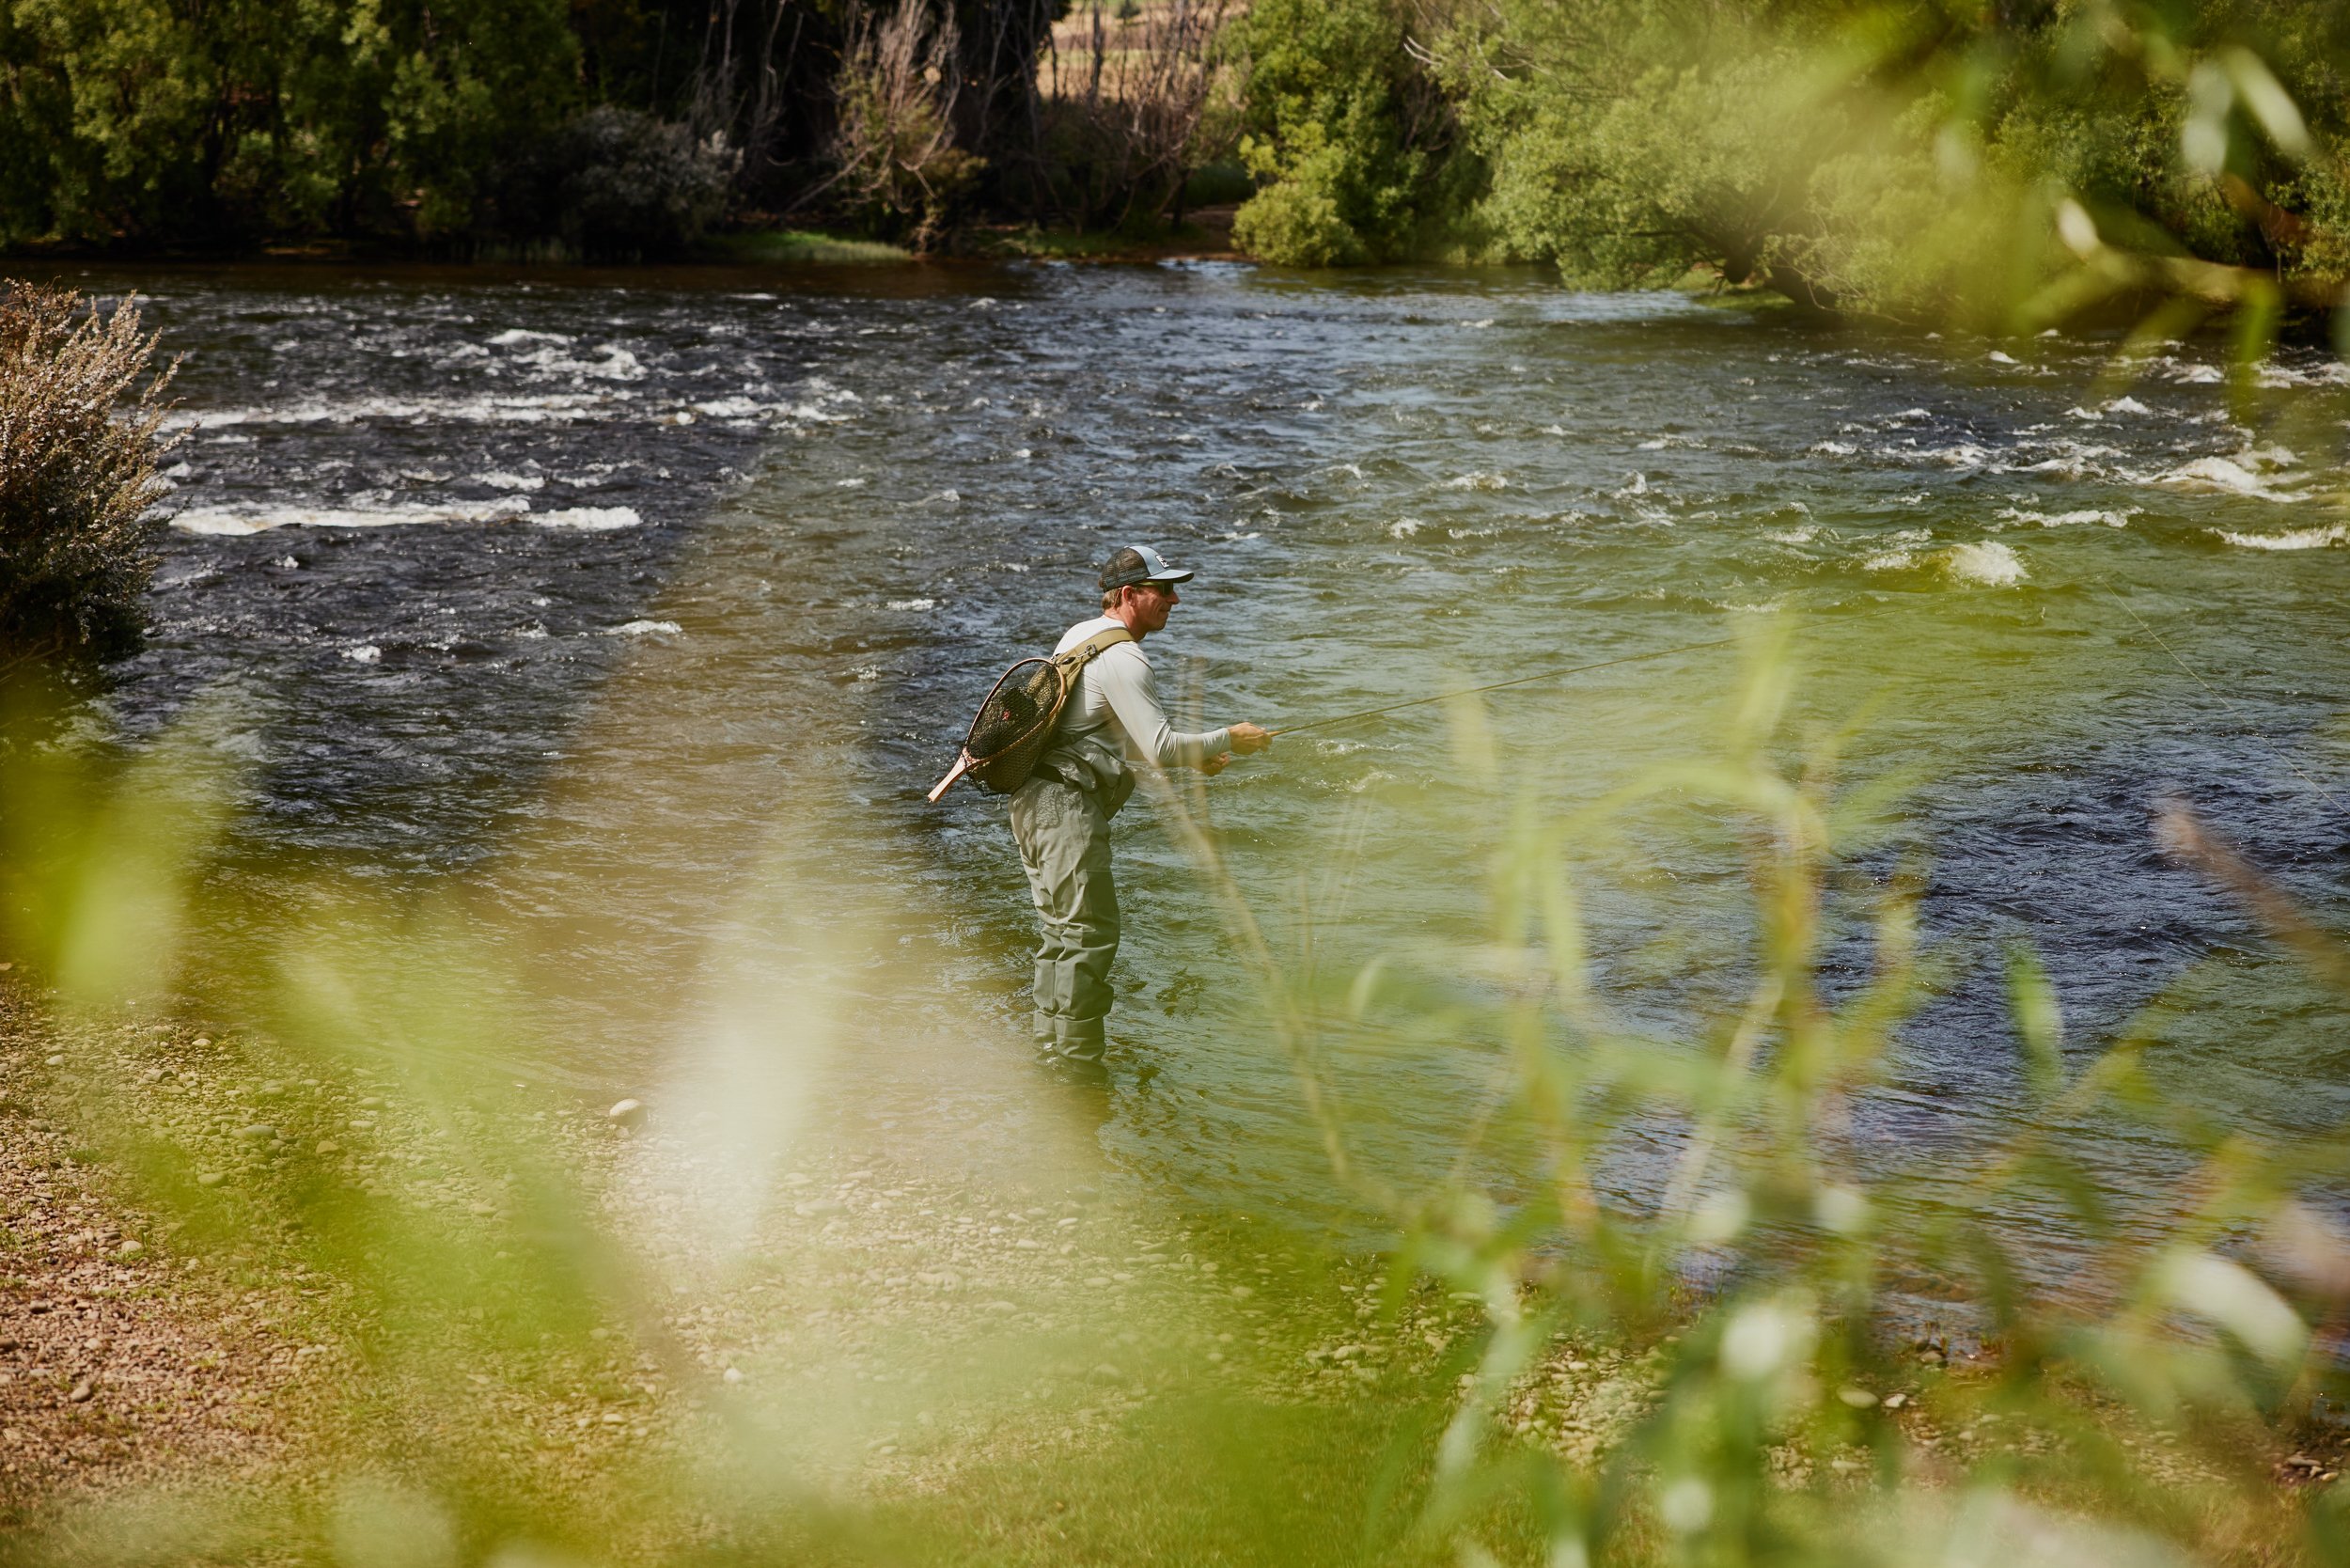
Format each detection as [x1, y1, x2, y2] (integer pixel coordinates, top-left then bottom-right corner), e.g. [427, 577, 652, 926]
[1010, 545, 1272, 1060]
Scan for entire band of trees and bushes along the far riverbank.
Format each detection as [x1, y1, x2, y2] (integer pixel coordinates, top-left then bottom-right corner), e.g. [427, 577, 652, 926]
[0, 0, 2350, 327]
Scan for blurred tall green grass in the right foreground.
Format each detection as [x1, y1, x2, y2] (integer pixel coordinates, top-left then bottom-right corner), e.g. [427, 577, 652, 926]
[1152, 630, 2350, 1563]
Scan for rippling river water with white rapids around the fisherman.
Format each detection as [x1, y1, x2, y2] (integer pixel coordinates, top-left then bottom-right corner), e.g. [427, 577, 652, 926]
[55, 263, 2350, 1269]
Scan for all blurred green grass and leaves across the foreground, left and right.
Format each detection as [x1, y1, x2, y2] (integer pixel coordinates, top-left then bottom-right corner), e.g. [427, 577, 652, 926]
[0, 630, 2350, 1568]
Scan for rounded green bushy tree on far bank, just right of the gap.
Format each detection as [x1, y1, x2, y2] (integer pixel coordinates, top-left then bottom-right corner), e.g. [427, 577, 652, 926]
[1234, 0, 1460, 266]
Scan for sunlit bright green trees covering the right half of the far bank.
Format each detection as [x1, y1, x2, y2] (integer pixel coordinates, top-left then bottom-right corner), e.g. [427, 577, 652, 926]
[1239, 0, 2350, 324]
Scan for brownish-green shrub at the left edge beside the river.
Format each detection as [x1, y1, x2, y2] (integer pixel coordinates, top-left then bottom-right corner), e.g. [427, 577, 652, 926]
[0, 287, 172, 672]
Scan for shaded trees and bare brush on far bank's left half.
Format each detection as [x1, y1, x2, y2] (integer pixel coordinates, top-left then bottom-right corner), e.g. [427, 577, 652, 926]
[0, 0, 1222, 259]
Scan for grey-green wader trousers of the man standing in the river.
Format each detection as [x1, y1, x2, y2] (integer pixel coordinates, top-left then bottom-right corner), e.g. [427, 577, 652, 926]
[1010, 774, 1119, 1060]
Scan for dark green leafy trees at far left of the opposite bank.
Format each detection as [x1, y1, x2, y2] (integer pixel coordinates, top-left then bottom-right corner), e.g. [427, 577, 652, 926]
[0, 0, 578, 244]
